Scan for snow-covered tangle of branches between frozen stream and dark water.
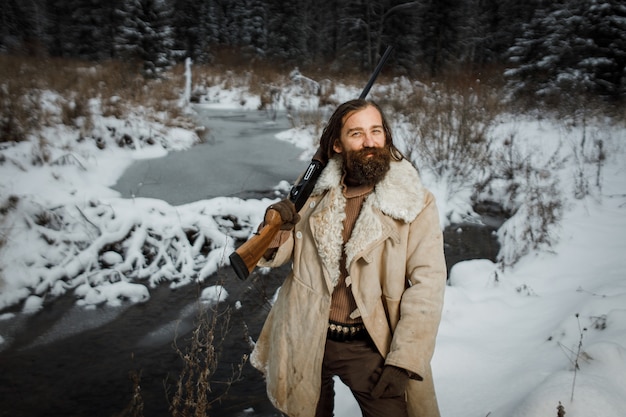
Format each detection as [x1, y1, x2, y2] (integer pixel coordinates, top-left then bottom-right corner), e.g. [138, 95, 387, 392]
[0, 198, 262, 309]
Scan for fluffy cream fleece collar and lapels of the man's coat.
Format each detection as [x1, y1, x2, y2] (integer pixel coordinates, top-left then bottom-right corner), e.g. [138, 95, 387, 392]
[311, 157, 425, 287]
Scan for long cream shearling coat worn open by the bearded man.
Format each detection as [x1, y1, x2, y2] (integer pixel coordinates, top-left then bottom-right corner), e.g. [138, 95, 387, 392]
[251, 158, 446, 417]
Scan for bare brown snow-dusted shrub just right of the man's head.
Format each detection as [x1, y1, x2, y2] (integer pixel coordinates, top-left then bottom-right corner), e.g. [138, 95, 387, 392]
[401, 78, 498, 195]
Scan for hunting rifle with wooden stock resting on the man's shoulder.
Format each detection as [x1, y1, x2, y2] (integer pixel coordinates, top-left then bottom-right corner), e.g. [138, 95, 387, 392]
[229, 46, 392, 280]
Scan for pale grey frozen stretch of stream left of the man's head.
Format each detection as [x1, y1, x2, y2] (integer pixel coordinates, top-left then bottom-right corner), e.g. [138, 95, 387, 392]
[114, 107, 309, 205]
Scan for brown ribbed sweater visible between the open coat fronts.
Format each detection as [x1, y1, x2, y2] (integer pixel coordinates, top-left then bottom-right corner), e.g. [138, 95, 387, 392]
[329, 186, 374, 325]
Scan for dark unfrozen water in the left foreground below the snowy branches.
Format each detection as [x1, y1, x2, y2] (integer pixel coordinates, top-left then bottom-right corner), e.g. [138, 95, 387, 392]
[0, 264, 286, 417]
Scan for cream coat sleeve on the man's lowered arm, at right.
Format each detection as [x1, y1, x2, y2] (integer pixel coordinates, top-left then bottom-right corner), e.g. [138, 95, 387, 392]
[386, 193, 447, 379]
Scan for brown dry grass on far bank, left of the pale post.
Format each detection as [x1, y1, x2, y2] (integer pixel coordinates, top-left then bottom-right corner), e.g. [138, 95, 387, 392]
[0, 54, 190, 142]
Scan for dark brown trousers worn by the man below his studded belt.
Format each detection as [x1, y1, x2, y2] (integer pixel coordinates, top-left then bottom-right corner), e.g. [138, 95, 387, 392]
[315, 338, 407, 417]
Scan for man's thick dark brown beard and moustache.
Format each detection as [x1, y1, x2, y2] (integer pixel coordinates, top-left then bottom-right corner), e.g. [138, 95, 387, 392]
[341, 146, 391, 185]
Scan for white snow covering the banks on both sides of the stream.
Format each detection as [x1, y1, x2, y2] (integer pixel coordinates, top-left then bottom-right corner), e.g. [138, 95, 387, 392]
[0, 72, 626, 417]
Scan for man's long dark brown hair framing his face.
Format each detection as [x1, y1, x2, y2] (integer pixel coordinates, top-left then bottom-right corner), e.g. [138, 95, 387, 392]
[320, 99, 404, 161]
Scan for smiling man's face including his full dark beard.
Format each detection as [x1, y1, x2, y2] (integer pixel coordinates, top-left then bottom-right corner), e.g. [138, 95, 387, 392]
[333, 106, 391, 185]
